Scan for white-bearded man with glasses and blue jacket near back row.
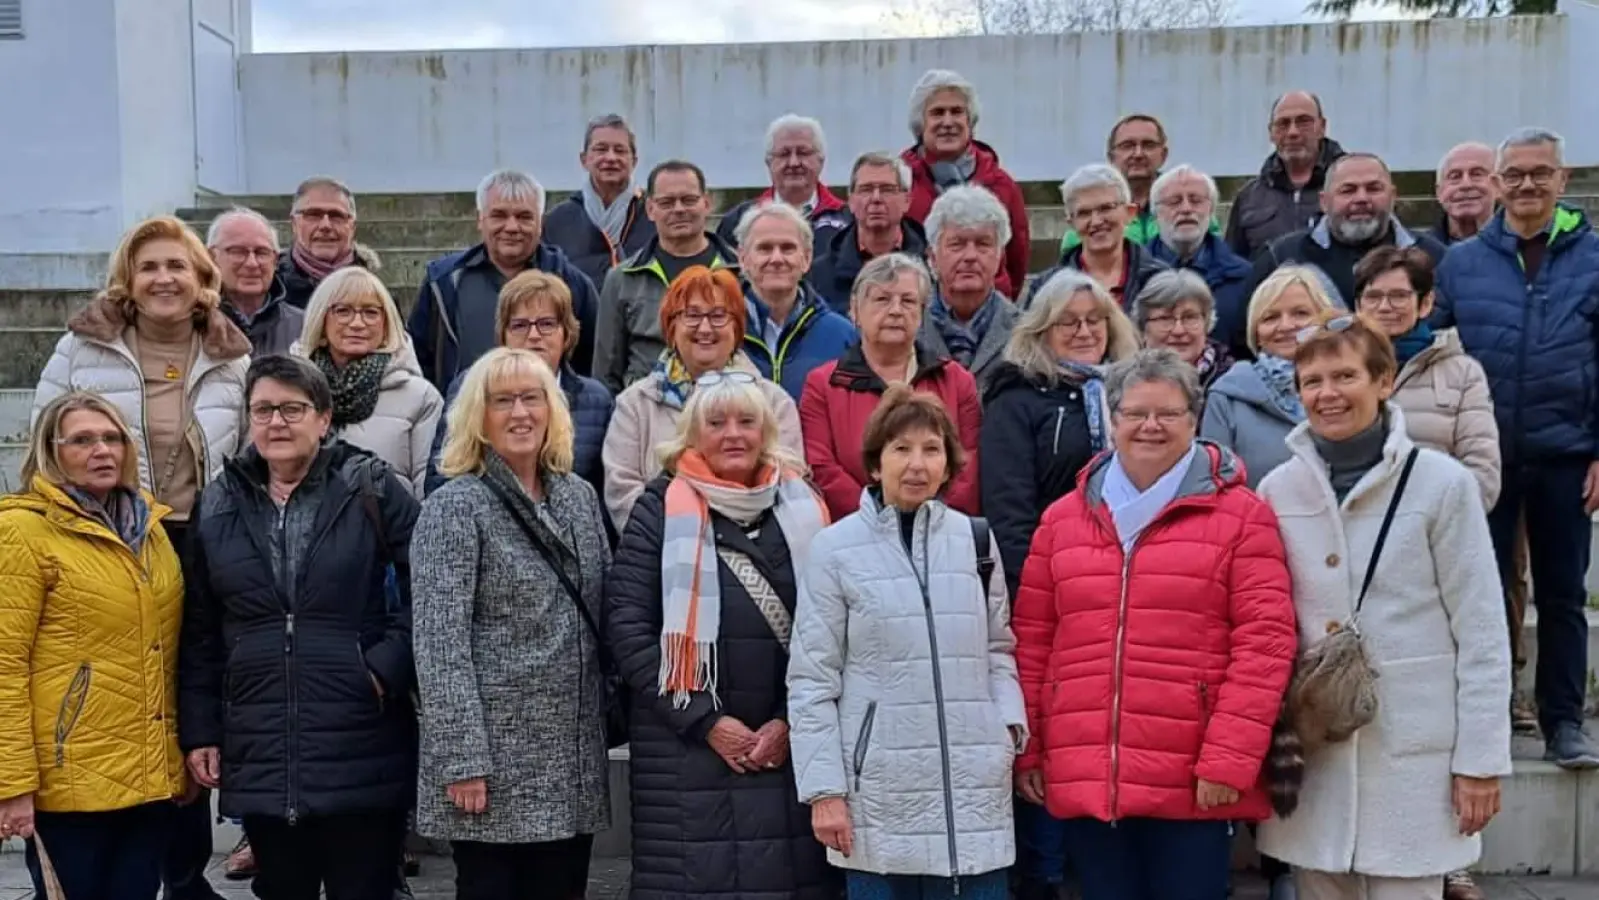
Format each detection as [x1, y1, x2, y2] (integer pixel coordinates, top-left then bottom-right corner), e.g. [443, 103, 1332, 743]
[1150, 165, 1250, 351]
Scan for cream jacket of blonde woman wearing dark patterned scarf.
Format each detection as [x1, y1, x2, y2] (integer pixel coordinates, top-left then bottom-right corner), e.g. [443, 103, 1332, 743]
[289, 337, 445, 499]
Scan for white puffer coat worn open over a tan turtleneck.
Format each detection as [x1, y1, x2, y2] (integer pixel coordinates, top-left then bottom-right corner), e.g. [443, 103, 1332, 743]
[29, 297, 249, 491]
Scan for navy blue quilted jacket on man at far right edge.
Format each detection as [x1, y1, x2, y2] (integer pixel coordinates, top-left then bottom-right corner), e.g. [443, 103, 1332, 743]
[1433, 206, 1599, 467]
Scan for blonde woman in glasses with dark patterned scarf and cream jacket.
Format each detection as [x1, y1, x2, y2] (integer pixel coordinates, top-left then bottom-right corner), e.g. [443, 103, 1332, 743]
[289, 265, 445, 497]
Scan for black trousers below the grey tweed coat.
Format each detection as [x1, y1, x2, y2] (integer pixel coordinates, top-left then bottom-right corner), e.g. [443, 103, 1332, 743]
[454, 834, 595, 900]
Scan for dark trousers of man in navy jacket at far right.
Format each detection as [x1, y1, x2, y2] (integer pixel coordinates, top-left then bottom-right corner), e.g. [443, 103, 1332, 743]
[1489, 459, 1593, 735]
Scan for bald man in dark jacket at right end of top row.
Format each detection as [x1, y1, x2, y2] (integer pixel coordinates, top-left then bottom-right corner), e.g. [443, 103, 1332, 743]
[1226, 91, 1343, 259]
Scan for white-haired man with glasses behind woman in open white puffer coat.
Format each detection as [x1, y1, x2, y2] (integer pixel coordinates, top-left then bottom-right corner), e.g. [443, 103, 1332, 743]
[205, 206, 305, 356]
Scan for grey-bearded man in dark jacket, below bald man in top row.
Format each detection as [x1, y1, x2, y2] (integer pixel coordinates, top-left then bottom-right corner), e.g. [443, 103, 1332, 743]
[1234, 153, 1445, 334]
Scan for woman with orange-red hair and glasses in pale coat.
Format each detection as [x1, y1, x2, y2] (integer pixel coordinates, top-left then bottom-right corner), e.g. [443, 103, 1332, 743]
[600, 265, 803, 532]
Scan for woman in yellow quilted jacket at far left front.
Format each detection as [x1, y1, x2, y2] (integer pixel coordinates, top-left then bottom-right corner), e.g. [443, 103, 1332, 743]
[0, 392, 187, 900]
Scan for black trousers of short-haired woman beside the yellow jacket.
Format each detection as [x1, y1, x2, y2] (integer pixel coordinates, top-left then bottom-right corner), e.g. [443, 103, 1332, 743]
[245, 810, 405, 900]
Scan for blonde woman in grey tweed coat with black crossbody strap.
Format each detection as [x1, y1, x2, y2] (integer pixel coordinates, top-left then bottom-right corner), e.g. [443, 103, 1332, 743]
[411, 347, 611, 900]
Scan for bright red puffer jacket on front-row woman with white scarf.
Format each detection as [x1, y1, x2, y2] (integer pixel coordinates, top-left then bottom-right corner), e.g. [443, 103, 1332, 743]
[1014, 441, 1298, 822]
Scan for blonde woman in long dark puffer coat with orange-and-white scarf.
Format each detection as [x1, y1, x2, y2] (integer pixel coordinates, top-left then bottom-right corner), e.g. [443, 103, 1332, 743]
[606, 369, 838, 900]
